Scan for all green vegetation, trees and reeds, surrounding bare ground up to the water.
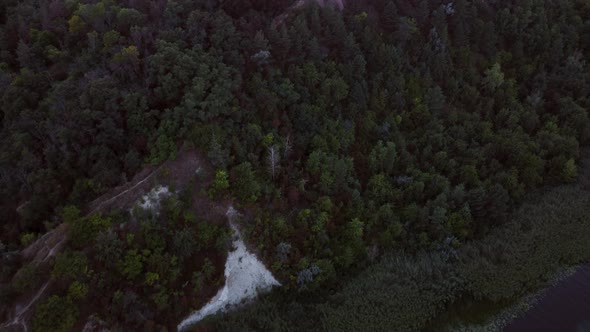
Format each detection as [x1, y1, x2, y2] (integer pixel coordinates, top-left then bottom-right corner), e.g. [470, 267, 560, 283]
[0, 0, 590, 331]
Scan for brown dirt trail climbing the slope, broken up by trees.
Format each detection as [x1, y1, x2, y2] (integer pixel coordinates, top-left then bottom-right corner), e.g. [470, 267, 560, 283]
[0, 150, 202, 332]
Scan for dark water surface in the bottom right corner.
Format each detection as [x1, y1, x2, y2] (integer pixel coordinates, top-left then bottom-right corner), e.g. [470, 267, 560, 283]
[504, 264, 590, 332]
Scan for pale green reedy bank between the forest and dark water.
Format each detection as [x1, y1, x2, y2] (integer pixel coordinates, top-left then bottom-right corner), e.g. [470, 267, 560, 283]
[206, 172, 590, 331]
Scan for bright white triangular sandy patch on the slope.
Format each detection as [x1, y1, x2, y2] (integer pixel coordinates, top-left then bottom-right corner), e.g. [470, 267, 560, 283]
[178, 206, 281, 331]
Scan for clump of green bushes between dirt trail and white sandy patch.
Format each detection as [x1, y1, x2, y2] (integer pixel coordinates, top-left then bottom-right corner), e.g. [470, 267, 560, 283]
[39, 188, 228, 330]
